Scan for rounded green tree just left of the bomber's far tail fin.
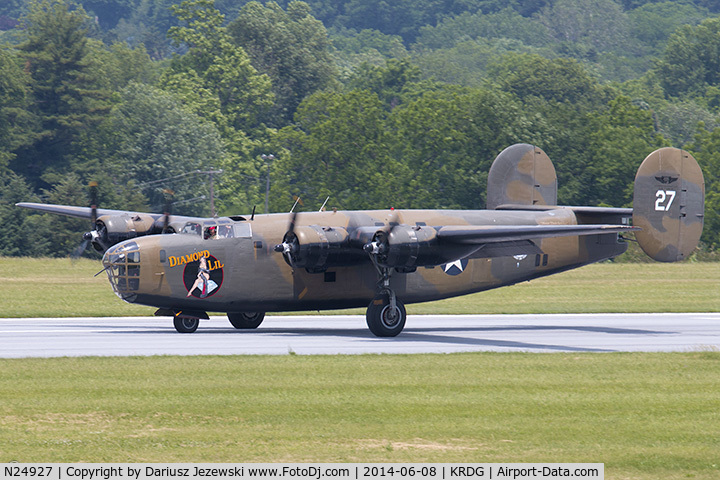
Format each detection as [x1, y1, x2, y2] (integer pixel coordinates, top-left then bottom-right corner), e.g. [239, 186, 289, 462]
[392, 86, 533, 208]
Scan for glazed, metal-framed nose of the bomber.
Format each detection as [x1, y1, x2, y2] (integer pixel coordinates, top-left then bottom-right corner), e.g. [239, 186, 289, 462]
[102, 241, 140, 302]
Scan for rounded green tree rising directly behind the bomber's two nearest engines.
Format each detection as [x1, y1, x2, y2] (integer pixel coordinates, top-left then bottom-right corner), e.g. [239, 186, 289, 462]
[272, 90, 394, 210]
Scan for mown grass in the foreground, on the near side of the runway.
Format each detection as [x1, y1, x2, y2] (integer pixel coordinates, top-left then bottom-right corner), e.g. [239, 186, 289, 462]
[0, 351, 720, 479]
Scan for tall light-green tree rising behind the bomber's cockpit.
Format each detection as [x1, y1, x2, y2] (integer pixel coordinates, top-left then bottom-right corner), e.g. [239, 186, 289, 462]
[160, 0, 274, 214]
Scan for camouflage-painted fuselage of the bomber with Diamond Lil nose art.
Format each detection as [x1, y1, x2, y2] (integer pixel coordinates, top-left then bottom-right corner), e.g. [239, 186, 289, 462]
[103, 207, 627, 312]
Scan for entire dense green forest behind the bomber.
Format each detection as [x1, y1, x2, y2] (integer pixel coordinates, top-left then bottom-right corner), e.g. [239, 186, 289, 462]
[0, 0, 720, 256]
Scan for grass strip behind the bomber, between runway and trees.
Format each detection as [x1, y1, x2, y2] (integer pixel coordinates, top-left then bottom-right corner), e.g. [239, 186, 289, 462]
[0, 257, 720, 317]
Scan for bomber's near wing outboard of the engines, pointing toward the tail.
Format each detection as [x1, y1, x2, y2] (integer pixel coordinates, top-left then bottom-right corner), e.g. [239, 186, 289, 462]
[437, 225, 640, 245]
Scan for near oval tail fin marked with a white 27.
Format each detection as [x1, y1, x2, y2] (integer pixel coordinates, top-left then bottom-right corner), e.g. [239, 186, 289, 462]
[633, 147, 705, 262]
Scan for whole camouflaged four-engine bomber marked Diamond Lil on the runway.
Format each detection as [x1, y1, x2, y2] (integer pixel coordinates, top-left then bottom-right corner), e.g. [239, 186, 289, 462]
[18, 144, 705, 337]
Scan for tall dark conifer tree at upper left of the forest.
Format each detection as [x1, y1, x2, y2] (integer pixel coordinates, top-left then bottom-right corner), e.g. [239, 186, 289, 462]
[11, 0, 110, 191]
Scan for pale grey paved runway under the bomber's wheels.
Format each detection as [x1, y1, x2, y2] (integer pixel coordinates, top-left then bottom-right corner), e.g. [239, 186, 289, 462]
[0, 313, 720, 358]
